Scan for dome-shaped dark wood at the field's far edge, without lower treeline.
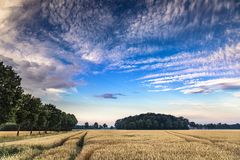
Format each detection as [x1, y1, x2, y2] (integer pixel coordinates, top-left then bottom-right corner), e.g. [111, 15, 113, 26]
[115, 113, 189, 130]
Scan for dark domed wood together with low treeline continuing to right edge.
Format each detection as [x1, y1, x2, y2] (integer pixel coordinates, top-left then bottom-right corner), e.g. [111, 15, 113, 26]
[115, 113, 240, 130]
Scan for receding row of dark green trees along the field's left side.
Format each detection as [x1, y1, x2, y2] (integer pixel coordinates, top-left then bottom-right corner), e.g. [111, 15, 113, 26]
[0, 62, 78, 135]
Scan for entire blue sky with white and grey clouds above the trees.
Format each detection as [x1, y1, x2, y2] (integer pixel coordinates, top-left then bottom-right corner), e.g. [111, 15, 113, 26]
[0, 0, 240, 125]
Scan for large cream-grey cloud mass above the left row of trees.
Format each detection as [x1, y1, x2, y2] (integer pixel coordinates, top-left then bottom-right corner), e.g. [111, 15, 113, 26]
[0, 1, 81, 97]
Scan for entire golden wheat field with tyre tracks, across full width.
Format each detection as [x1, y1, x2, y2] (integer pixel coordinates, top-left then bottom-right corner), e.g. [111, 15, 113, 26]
[0, 130, 240, 160]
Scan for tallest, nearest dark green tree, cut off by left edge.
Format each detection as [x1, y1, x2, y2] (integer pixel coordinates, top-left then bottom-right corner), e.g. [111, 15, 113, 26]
[0, 62, 23, 124]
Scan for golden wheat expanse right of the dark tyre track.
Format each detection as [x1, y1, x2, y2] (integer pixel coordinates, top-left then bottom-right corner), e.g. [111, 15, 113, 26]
[77, 130, 240, 160]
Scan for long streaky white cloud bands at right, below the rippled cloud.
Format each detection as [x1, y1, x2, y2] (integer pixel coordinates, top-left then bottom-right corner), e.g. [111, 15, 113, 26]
[132, 43, 240, 93]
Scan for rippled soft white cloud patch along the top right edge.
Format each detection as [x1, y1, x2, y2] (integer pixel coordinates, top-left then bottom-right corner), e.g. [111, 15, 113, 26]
[127, 0, 239, 39]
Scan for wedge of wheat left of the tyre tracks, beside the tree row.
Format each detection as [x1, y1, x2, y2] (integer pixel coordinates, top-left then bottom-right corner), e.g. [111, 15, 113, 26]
[0, 131, 82, 160]
